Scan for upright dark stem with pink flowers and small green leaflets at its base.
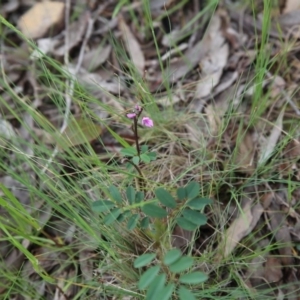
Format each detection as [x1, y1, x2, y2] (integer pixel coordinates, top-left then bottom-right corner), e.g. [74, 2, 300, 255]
[121, 105, 156, 166]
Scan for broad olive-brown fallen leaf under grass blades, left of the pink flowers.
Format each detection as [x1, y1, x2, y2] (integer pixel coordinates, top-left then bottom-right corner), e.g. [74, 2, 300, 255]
[57, 117, 101, 149]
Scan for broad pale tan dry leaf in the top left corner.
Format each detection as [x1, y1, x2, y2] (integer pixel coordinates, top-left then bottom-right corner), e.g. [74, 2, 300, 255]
[18, 1, 65, 39]
